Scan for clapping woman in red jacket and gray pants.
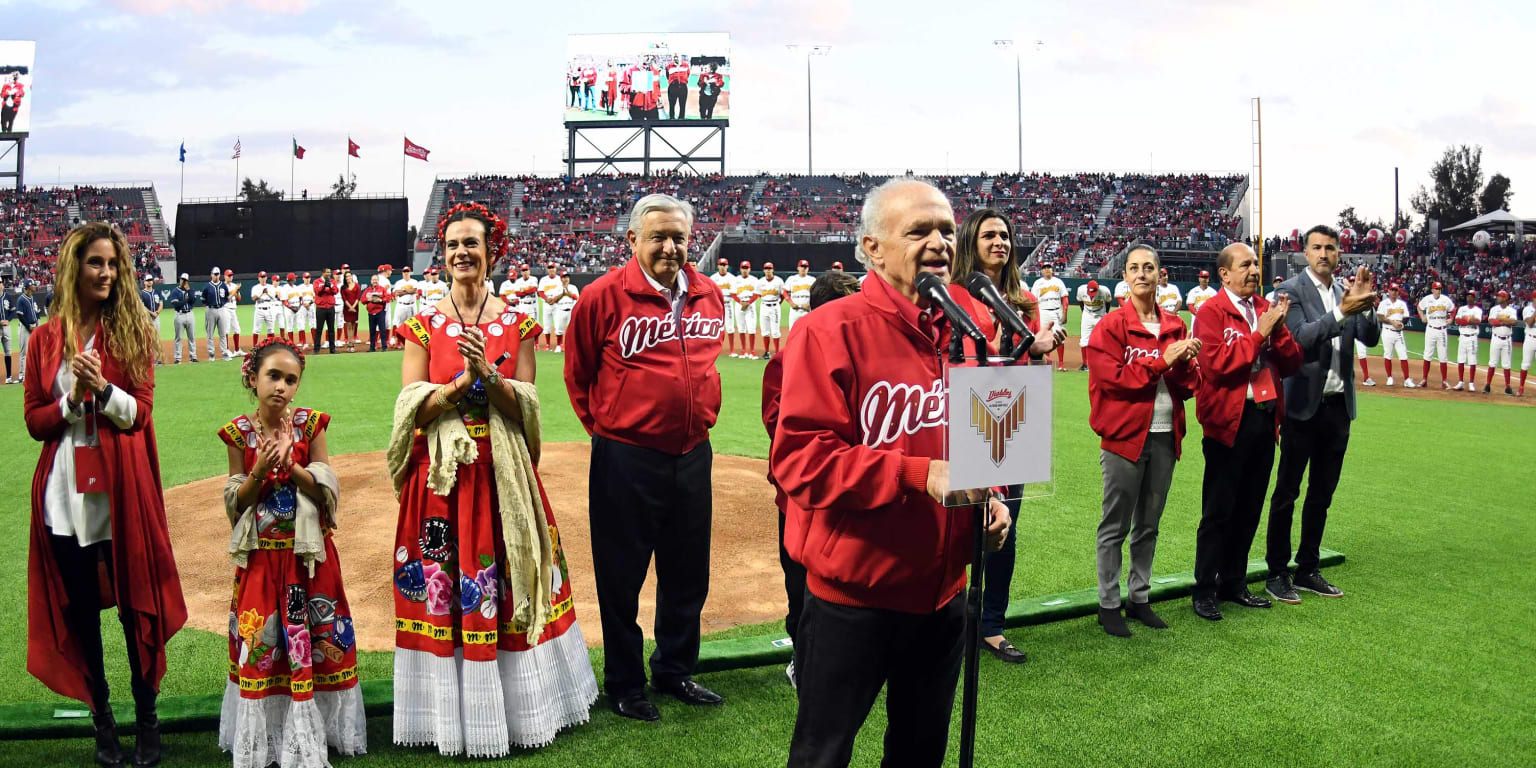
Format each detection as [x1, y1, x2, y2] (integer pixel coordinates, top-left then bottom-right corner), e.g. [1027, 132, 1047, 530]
[1083, 246, 1200, 637]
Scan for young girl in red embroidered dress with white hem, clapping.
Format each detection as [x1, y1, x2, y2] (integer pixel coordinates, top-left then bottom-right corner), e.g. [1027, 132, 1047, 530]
[218, 338, 367, 768]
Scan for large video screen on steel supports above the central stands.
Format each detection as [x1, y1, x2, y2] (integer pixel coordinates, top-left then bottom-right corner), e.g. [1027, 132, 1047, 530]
[562, 32, 731, 124]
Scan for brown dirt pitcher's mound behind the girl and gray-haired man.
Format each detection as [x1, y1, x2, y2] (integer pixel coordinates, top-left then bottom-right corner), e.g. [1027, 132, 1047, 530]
[166, 442, 785, 650]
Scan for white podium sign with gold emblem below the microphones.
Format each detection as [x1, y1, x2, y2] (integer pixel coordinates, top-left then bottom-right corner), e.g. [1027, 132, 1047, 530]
[948, 366, 1052, 488]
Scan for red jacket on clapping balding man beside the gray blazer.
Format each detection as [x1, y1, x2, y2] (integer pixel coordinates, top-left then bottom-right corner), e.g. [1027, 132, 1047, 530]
[1195, 287, 1301, 447]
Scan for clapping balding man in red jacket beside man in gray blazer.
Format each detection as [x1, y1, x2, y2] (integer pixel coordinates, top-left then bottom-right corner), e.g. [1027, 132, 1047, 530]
[1195, 243, 1301, 621]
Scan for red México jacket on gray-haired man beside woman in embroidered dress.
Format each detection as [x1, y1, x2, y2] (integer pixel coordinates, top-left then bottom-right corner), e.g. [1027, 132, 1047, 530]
[565, 258, 725, 456]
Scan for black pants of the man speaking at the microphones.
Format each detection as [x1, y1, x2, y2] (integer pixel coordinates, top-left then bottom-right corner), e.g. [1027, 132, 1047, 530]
[790, 591, 965, 768]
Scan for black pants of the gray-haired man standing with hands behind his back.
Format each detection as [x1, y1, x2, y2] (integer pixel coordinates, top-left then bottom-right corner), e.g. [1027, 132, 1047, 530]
[587, 436, 714, 697]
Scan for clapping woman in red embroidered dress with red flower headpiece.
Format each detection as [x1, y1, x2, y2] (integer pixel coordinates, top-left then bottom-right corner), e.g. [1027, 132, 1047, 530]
[392, 203, 598, 757]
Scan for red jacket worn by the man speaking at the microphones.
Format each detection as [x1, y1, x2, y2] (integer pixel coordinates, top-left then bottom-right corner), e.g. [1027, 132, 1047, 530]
[770, 273, 971, 614]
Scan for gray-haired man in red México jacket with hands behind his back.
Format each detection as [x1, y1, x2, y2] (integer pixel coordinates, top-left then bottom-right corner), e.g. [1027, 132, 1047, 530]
[565, 195, 725, 720]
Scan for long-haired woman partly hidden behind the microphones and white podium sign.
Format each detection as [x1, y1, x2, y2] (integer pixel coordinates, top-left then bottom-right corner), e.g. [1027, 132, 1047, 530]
[949, 207, 1066, 664]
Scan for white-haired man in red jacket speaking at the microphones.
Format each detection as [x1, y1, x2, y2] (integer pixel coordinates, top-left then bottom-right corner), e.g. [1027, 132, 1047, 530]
[771, 178, 1011, 766]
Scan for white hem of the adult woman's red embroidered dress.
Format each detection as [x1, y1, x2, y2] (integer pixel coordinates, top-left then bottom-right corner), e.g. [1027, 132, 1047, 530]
[395, 624, 598, 757]
